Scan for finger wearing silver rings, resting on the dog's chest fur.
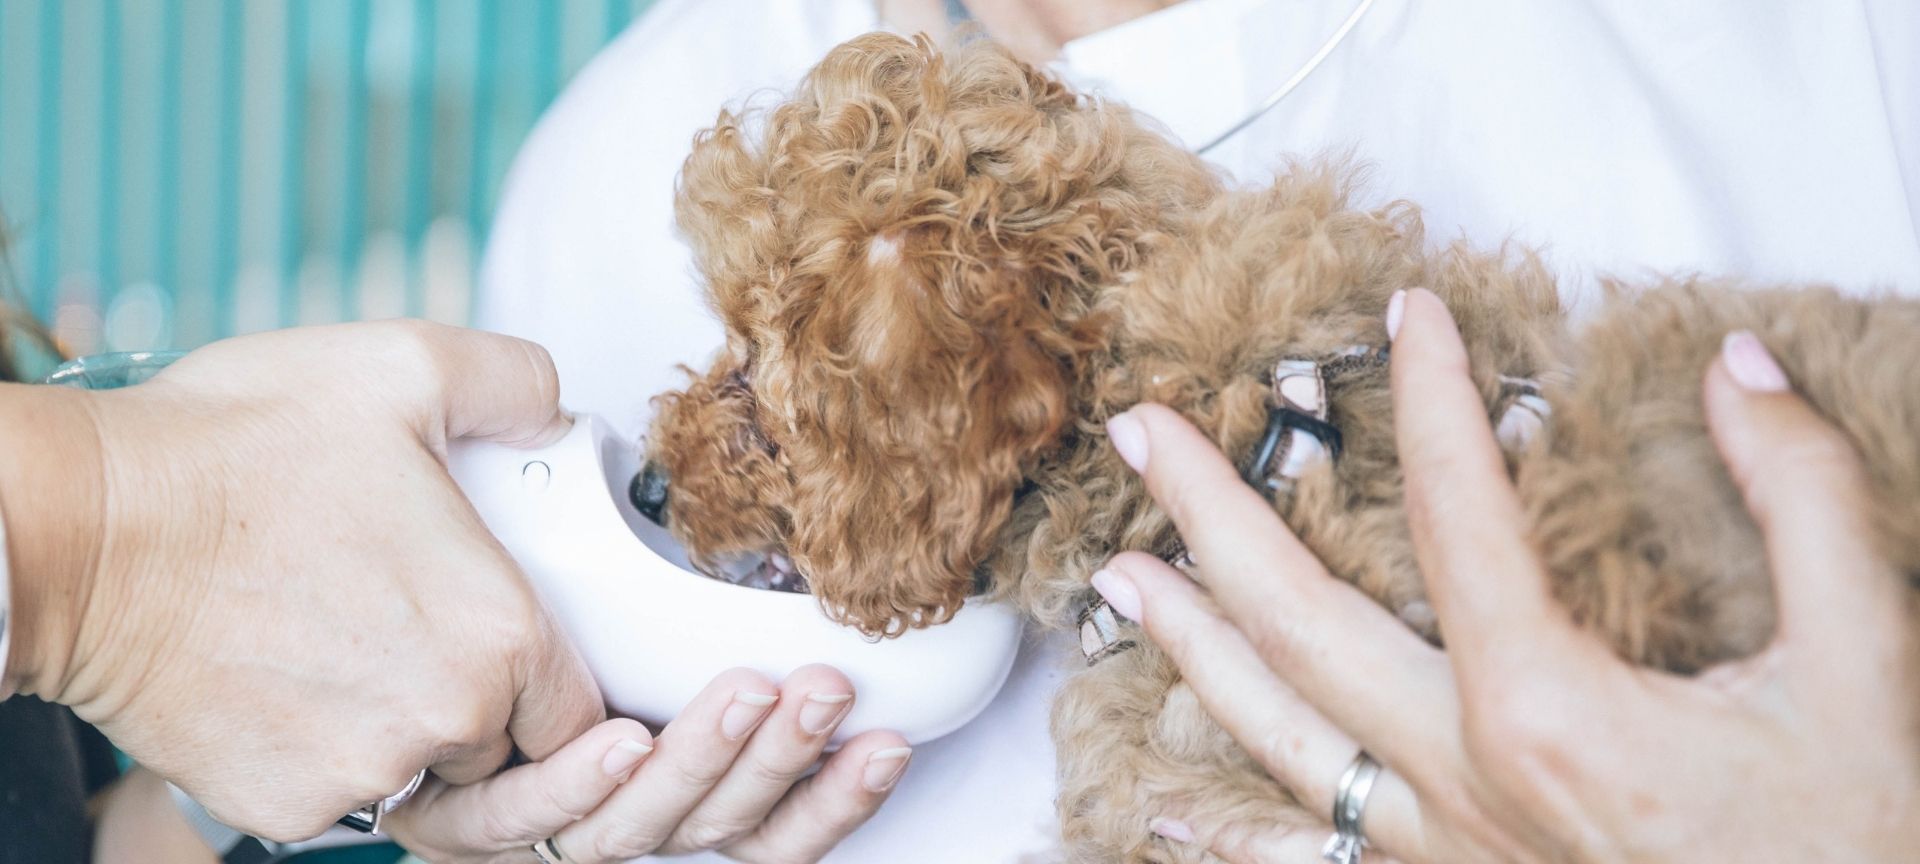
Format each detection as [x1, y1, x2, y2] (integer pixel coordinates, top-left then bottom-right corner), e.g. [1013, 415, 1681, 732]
[1094, 553, 1436, 860]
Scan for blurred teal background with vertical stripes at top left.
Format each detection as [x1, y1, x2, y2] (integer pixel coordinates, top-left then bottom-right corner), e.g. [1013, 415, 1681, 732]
[0, 0, 651, 353]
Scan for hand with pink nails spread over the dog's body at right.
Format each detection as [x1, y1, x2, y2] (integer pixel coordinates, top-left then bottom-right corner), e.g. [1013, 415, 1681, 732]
[1096, 290, 1920, 862]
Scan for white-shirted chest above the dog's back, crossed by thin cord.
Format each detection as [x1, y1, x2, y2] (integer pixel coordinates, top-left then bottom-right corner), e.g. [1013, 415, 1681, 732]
[1064, 0, 1920, 307]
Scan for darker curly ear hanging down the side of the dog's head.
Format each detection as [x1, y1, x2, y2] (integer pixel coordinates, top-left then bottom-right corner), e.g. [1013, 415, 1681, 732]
[756, 232, 1092, 636]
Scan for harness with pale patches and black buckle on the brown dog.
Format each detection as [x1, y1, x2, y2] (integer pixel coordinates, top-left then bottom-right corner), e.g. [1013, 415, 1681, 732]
[1079, 346, 1551, 666]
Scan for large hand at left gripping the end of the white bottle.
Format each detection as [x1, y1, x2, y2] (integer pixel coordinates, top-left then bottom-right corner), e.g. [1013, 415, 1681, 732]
[0, 323, 605, 841]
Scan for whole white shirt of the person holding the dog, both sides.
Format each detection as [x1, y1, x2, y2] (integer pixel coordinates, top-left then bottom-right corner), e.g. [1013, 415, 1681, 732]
[478, 0, 1920, 864]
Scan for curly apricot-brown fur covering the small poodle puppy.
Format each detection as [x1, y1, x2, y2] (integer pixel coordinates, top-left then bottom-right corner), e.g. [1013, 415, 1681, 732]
[649, 35, 1920, 862]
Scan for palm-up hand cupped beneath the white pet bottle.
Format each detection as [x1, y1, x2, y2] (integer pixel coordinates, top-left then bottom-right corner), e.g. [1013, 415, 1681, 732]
[388, 666, 910, 864]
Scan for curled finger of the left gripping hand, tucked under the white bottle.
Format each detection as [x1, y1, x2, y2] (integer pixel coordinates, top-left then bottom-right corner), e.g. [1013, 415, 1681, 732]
[507, 614, 607, 760]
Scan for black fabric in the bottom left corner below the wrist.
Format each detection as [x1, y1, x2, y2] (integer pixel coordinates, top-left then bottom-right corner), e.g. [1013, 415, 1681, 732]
[0, 697, 119, 864]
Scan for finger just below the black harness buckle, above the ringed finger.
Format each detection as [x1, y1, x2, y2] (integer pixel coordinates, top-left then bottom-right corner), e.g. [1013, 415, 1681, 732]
[1108, 405, 1453, 775]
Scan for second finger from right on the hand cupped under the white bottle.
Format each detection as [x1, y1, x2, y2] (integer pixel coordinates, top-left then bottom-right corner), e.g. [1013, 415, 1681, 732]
[660, 666, 854, 854]
